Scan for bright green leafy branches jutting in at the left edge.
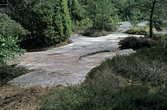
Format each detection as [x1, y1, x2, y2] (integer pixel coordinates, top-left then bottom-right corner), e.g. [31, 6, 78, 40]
[0, 35, 25, 66]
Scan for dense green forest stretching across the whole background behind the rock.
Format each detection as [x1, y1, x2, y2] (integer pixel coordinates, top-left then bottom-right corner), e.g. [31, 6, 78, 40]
[0, 0, 167, 64]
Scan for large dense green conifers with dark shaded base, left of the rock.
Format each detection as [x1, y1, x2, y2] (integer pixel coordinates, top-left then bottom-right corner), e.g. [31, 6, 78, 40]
[8, 0, 71, 48]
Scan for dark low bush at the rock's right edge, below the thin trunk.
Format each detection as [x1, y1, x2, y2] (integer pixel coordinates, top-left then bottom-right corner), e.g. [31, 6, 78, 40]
[119, 36, 157, 50]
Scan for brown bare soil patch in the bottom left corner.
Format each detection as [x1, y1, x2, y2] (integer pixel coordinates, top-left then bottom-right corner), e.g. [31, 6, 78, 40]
[0, 85, 49, 110]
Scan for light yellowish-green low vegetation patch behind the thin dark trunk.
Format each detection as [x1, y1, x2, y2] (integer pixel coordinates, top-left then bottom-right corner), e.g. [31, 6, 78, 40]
[124, 26, 156, 35]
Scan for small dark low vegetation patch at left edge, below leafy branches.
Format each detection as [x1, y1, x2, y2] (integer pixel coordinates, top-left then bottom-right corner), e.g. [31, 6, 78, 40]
[0, 66, 29, 86]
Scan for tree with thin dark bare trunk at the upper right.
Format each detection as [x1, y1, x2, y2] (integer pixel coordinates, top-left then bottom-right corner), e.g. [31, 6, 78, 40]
[135, 0, 167, 38]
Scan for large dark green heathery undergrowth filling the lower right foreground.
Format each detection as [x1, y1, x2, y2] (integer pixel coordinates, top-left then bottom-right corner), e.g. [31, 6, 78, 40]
[38, 47, 167, 110]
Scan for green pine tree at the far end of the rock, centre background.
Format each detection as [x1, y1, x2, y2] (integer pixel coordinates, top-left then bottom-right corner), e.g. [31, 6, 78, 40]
[87, 0, 118, 30]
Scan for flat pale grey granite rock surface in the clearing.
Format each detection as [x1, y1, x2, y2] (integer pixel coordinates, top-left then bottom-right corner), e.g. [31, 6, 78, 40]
[8, 33, 138, 88]
